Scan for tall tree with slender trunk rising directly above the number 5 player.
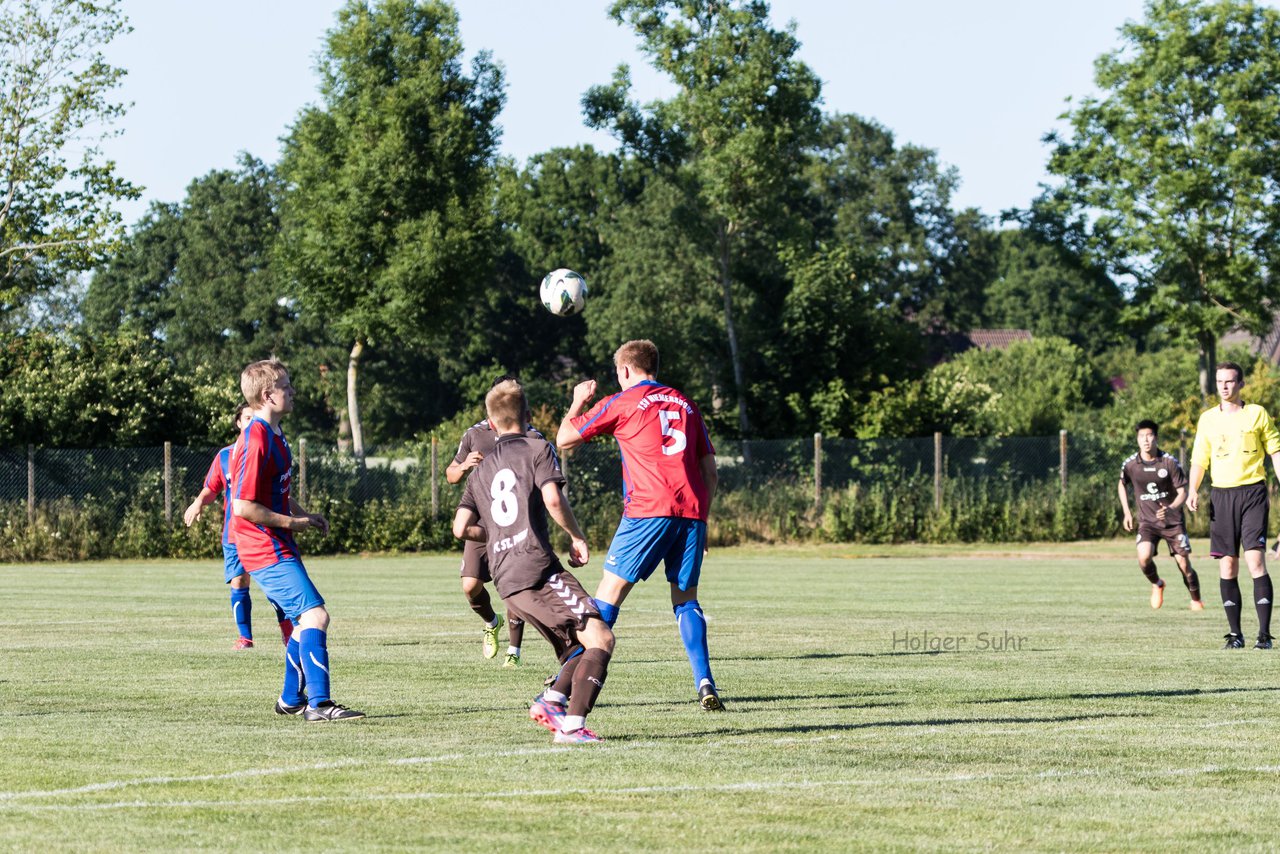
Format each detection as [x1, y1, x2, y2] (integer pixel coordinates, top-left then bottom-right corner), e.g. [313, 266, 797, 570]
[582, 0, 820, 437]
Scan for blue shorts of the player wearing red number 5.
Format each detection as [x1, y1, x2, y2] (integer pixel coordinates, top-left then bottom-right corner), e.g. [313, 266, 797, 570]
[604, 516, 707, 590]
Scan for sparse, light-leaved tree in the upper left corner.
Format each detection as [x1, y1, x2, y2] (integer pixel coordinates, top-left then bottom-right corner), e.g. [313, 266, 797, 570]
[0, 0, 140, 312]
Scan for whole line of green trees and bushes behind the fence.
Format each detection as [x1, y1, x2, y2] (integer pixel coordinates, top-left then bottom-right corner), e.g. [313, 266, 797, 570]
[0, 0, 1280, 456]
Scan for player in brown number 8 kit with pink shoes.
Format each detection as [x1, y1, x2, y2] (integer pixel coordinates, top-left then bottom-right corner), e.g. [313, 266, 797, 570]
[453, 380, 613, 744]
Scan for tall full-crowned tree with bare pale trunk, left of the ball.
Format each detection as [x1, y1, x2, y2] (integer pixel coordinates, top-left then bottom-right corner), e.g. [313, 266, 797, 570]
[279, 0, 503, 457]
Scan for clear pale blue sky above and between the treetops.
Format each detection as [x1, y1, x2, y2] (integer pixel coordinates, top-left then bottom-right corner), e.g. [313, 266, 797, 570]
[108, 0, 1143, 224]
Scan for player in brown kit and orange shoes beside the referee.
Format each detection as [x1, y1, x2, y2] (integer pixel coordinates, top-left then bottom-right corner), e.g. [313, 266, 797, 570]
[1117, 421, 1204, 611]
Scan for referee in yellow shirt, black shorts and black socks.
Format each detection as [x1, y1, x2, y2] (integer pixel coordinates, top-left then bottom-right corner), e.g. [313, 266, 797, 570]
[1187, 362, 1280, 649]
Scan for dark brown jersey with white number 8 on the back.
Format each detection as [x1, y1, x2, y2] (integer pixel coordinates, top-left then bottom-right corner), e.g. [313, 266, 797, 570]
[458, 433, 564, 599]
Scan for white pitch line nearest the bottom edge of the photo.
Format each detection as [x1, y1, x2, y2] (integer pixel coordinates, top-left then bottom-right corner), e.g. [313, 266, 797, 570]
[9, 768, 1280, 812]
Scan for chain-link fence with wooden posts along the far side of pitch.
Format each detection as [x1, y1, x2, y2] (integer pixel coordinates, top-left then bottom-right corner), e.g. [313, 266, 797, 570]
[0, 433, 1203, 561]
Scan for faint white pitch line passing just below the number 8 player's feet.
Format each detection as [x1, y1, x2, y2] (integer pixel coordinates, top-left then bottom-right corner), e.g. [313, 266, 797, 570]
[0, 721, 1259, 809]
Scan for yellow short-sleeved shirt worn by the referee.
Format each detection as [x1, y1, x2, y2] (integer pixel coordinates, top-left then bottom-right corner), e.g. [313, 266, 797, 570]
[1192, 403, 1280, 488]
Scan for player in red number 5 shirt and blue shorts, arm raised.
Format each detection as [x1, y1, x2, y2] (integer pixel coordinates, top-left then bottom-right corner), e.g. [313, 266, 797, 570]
[556, 341, 724, 712]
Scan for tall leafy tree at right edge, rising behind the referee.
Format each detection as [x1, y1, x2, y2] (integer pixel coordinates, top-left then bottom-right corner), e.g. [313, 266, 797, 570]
[1046, 0, 1280, 396]
